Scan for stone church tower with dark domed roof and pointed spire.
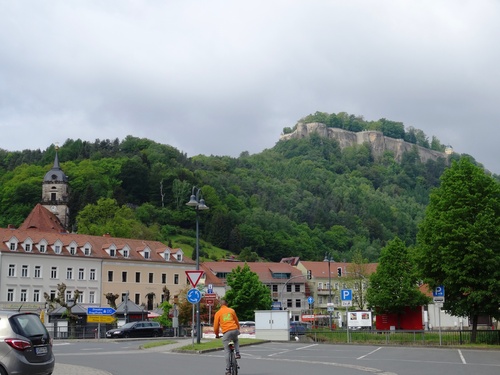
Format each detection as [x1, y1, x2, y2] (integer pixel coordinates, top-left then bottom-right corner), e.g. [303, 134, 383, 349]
[41, 147, 69, 229]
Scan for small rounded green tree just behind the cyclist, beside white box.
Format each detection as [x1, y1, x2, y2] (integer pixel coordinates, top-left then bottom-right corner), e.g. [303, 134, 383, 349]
[224, 264, 272, 320]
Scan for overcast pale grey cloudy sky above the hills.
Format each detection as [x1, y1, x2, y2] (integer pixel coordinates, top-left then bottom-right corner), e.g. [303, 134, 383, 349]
[0, 0, 500, 174]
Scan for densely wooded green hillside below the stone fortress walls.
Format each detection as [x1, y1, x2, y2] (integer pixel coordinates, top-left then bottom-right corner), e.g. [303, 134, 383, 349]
[0, 130, 472, 261]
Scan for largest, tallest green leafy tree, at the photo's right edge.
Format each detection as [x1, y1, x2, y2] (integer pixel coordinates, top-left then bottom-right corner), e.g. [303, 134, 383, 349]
[416, 158, 500, 340]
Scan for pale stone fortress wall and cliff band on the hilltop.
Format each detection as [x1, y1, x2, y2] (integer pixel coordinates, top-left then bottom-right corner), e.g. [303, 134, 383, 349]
[280, 122, 448, 163]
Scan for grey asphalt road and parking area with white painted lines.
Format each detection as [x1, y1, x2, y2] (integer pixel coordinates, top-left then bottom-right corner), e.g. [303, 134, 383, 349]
[54, 340, 500, 375]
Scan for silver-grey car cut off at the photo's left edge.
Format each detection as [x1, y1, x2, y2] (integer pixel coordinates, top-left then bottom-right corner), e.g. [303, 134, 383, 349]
[0, 311, 55, 375]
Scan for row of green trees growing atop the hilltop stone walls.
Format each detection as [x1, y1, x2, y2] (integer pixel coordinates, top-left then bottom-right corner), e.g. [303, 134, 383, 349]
[283, 112, 446, 152]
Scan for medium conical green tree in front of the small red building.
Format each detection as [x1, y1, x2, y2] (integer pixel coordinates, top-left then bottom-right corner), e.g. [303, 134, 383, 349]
[366, 237, 429, 328]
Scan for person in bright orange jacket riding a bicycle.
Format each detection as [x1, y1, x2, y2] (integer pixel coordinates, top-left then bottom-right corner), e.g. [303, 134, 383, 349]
[214, 299, 241, 375]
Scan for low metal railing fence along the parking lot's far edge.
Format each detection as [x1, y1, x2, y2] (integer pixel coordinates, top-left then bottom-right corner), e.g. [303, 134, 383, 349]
[306, 330, 500, 346]
